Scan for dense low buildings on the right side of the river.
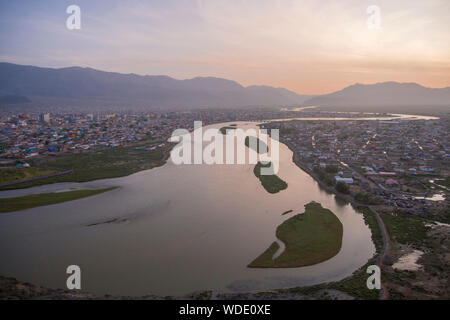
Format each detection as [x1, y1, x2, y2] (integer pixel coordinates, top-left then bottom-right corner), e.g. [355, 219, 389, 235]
[265, 119, 450, 216]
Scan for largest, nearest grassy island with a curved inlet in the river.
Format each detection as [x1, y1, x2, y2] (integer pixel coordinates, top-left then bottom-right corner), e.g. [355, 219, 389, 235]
[248, 202, 343, 268]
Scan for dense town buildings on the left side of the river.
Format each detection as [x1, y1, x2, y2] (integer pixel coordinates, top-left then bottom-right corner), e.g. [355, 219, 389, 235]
[0, 109, 380, 160]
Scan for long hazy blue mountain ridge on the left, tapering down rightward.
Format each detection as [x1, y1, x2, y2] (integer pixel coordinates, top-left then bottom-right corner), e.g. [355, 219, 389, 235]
[0, 63, 312, 108]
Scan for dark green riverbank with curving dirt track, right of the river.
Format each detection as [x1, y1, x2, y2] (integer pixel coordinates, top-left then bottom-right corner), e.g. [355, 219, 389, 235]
[270, 124, 450, 299]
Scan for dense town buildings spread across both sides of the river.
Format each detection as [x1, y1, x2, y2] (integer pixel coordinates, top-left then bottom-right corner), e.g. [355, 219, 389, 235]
[0, 108, 450, 218]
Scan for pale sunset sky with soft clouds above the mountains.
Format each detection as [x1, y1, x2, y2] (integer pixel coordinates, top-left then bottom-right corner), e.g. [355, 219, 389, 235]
[0, 0, 450, 94]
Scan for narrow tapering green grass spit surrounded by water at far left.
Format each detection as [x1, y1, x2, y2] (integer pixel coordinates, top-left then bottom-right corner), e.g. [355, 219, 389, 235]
[0, 187, 116, 212]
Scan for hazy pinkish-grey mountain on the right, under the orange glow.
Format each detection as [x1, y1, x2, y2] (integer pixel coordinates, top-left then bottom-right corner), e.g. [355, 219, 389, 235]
[304, 82, 450, 110]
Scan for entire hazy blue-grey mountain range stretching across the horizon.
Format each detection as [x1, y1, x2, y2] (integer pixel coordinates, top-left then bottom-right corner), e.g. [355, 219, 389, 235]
[0, 62, 450, 111]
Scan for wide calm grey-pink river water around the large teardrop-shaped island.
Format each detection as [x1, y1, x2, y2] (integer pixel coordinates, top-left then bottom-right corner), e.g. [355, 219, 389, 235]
[0, 117, 422, 295]
